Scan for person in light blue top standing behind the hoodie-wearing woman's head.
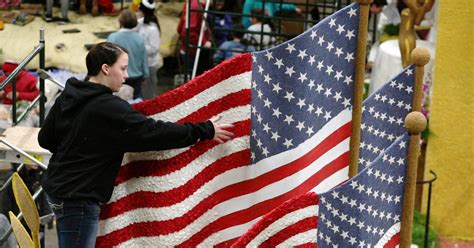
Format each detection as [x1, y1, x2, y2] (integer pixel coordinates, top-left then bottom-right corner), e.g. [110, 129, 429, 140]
[107, 9, 149, 99]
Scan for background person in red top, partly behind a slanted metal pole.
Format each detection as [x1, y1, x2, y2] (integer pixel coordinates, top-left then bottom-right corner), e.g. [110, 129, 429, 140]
[177, 0, 213, 76]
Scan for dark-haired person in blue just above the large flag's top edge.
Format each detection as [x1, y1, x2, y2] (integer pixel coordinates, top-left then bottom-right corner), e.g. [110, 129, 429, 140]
[214, 24, 255, 64]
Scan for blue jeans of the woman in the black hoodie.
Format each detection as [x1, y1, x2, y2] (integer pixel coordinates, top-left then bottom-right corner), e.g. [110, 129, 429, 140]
[47, 195, 100, 248]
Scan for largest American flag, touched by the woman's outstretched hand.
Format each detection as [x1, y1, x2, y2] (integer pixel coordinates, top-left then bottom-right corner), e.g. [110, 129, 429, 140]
[97, 4, 359, 247]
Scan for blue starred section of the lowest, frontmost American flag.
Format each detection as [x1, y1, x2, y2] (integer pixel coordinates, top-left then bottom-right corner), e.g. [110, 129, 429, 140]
[317, 132, 409, 247]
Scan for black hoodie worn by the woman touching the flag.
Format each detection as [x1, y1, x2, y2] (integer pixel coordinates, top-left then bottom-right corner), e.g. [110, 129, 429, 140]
[38, 78, 214, 202]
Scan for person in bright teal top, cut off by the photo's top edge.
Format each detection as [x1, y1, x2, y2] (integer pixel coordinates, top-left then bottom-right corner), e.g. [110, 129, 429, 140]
[242, 0, 301, 28]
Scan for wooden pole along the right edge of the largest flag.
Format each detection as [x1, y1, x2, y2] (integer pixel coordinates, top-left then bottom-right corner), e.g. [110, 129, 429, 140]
[349, 0, 372, 177]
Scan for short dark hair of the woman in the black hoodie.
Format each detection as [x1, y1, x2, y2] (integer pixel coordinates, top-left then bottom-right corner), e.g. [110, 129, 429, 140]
[86, 42, 128, 77]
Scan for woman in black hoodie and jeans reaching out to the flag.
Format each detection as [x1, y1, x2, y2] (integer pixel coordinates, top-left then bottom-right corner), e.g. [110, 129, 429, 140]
[38, 42, 233, 247]
